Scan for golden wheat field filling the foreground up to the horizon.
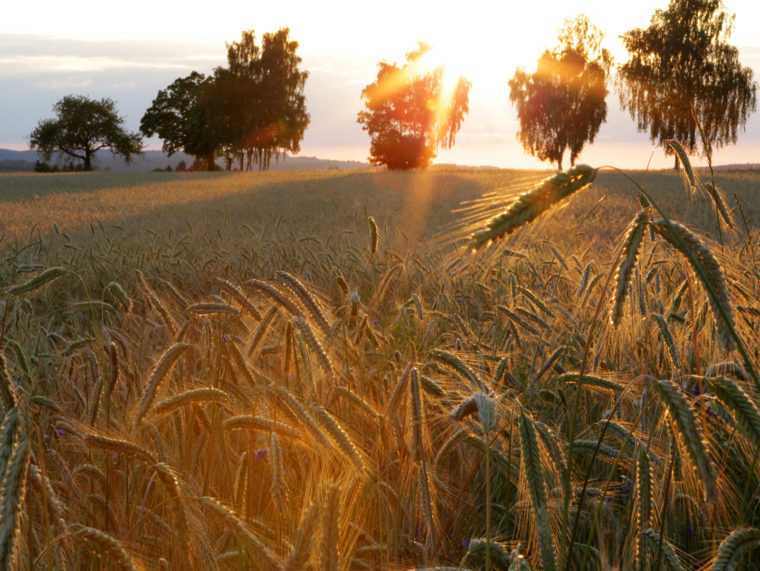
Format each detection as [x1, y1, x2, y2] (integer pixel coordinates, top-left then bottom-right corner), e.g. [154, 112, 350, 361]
[0, 163, 760, 571]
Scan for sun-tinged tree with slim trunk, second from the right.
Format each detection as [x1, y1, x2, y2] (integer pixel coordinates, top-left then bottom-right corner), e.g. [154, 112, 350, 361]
[509, 16, 612, 170]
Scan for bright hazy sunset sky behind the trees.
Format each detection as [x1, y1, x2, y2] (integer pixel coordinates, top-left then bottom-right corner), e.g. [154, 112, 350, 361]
[0, 0, 760, 168]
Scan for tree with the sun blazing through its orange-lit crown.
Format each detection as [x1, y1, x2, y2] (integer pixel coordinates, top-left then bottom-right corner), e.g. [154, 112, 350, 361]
[357, 43, 472, 170]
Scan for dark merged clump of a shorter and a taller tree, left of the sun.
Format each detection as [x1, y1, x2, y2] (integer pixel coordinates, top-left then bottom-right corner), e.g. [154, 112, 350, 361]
[141, 28, 309, 170]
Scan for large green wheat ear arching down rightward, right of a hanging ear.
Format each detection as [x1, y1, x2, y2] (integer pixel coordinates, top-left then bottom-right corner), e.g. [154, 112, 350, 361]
[652, 220, 736, 351]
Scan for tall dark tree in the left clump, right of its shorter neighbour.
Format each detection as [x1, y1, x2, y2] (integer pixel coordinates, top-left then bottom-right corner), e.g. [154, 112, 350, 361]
[207, 28, 310, 170]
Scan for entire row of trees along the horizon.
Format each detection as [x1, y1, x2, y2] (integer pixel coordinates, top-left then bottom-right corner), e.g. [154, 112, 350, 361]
[30, 0, 757, 170]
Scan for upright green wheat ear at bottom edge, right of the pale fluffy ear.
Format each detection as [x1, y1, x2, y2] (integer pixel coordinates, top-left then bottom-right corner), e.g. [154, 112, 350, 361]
[520, 414, 557, 571]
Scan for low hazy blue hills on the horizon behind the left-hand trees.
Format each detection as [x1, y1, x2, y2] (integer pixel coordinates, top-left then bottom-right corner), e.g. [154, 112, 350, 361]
[0, 149, 369, 172]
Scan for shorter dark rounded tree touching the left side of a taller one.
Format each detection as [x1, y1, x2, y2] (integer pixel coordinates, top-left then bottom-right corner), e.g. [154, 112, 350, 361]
[140, 71, 220, 170]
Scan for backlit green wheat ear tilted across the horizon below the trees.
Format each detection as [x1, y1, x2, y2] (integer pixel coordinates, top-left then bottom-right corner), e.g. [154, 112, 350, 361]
[467, 165, 598, 250]
